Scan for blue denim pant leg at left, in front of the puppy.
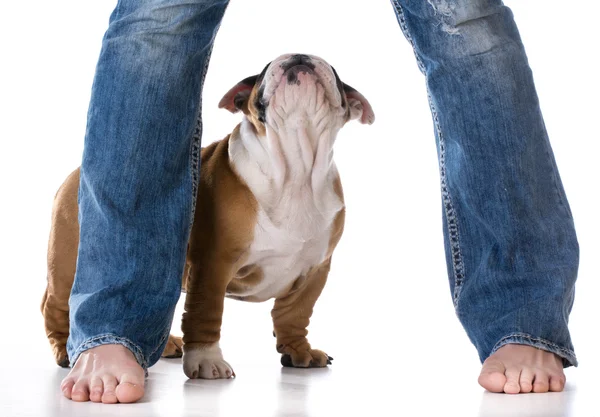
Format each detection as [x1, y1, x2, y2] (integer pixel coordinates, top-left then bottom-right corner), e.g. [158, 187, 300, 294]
[67, 0, 228, 369]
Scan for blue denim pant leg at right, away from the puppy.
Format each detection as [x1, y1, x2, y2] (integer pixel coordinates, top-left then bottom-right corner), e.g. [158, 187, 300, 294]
[392, 0, 579, 366]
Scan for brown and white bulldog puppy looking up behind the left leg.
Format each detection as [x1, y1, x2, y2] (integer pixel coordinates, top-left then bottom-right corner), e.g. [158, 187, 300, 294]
[42, 54, 375, 379]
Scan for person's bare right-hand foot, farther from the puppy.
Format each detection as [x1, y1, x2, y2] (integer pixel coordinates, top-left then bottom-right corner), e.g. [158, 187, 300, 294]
[479, 344, 565, 394]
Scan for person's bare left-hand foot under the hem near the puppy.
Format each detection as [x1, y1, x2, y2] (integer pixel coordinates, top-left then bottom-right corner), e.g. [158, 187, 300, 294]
[60, 345, 144, 404]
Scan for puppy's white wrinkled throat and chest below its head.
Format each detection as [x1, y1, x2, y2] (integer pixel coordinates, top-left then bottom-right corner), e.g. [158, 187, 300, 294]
[229, 115, 344, 301]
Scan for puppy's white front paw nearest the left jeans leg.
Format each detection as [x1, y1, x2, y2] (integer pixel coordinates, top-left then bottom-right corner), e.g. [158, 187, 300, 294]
[183, 343, 235, 379]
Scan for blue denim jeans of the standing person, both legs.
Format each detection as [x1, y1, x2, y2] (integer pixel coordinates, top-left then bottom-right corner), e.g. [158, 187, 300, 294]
[67, 0, 579, 368]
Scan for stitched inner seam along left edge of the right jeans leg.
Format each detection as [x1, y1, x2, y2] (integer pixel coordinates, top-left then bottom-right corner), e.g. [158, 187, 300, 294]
[391, 0, 465, 308]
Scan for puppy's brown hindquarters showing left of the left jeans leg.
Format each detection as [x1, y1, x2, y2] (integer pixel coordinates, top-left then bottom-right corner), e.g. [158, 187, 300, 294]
[41, 169, 79, 367]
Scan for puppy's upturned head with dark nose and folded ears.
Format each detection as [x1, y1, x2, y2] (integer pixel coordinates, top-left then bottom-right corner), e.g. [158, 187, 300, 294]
[219, 54, 375, 135]
